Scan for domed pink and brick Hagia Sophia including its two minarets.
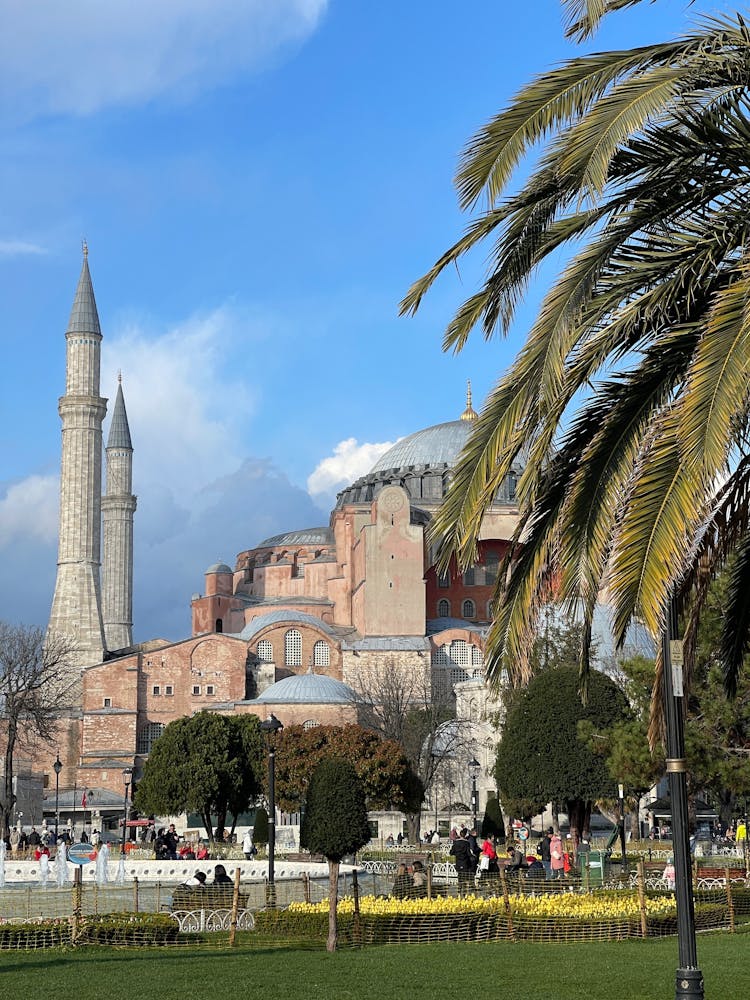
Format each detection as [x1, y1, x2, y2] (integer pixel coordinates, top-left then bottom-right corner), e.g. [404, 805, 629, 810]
[29, 248, 521, 836]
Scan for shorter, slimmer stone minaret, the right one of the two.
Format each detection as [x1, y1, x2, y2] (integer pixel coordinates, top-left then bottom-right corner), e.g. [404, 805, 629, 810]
[102, 375, 136, 650]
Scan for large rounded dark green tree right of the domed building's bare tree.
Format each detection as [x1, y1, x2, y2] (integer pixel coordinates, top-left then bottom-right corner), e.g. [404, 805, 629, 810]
[495, 667, 630, 843]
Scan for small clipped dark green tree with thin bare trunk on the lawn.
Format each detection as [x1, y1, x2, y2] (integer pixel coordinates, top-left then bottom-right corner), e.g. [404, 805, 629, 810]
[300, 758, 370, 951]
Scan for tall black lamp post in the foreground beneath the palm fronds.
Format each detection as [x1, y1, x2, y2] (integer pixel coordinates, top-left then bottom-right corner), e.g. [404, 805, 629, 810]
[662, 597, 704, 1000]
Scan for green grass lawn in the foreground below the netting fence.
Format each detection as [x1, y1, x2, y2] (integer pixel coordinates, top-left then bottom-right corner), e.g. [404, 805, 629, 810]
[0, 934, 750, 1000]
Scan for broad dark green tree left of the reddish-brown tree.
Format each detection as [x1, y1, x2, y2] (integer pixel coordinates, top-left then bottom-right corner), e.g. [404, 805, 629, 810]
[133, 712, 264, 840]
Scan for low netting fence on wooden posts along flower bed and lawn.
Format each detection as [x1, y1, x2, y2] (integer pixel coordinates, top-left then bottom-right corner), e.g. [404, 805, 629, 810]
[0, 859, 750, 949]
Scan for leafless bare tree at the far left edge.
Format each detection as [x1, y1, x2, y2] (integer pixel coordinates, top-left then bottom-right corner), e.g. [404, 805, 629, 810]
[0, 622, 79, 837]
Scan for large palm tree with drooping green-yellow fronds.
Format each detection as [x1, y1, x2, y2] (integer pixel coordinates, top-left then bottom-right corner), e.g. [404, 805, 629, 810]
[402, 0, 750, 712]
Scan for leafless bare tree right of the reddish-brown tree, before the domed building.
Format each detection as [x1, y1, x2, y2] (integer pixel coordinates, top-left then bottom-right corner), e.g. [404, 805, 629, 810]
[350, 656, 471, 842]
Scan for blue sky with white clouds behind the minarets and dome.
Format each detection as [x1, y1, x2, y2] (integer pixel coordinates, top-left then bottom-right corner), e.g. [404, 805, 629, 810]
[0, 0, 694, 639]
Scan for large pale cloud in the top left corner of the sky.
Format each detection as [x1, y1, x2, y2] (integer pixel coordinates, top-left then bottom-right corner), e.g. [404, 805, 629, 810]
[0, 0, 328, 114]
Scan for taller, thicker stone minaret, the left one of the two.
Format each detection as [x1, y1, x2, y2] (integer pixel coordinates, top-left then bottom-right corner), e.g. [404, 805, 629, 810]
[49, 243, 107, 667]
